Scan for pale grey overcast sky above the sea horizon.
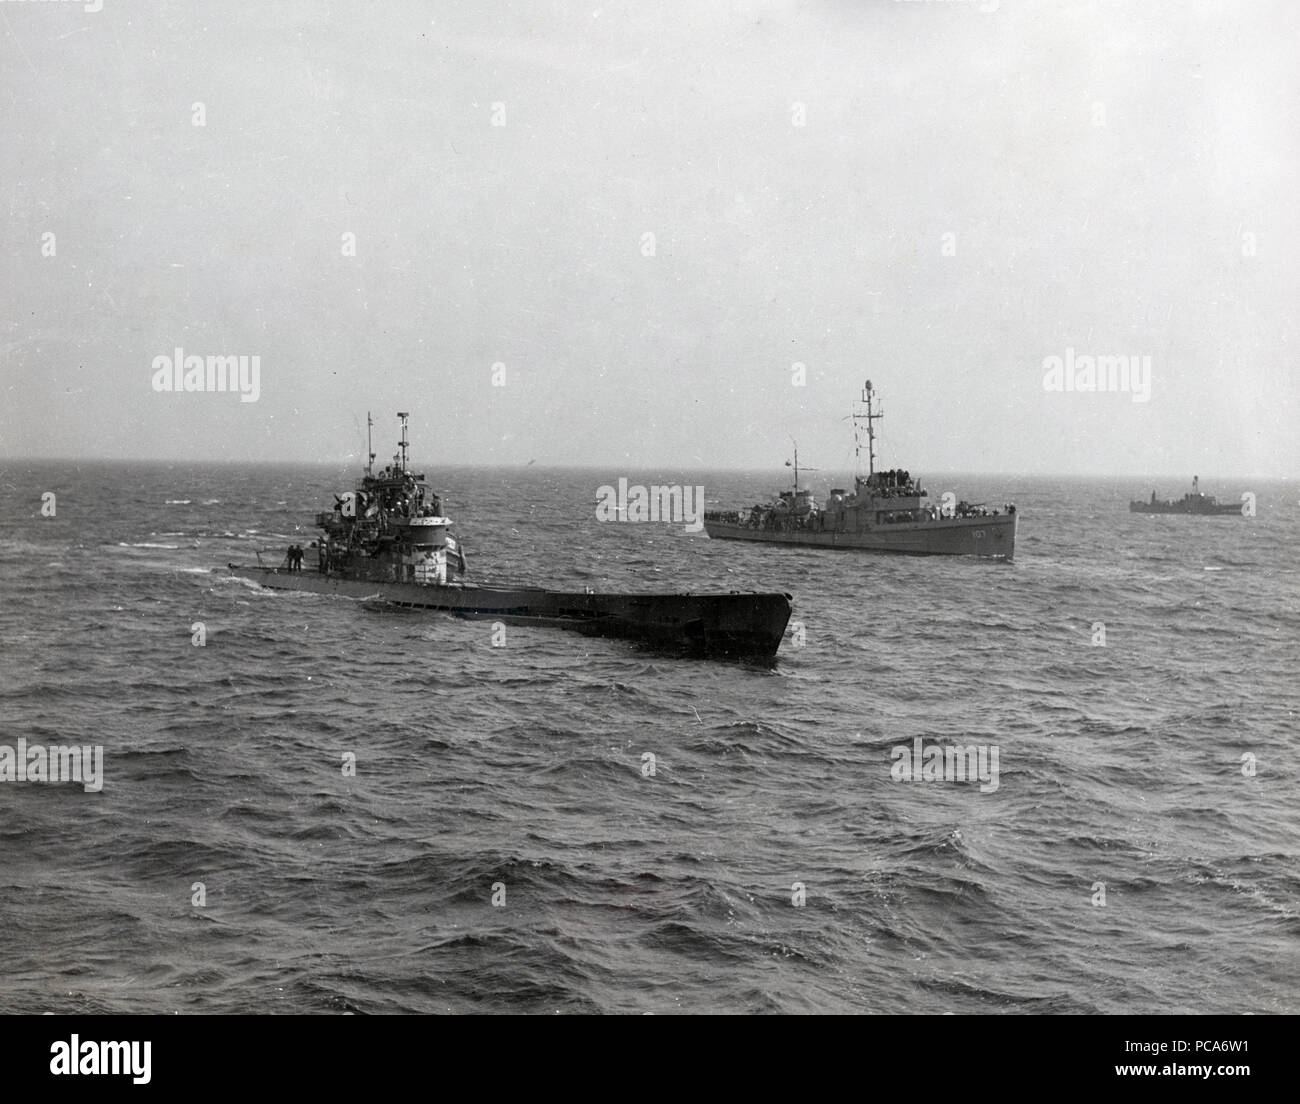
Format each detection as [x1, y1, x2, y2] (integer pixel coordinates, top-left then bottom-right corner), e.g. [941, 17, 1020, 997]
[0, 0, 1300, 479]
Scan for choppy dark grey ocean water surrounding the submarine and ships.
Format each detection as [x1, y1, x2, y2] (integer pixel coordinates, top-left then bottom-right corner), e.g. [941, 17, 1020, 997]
[0, 462, 1300, 1013]
